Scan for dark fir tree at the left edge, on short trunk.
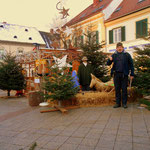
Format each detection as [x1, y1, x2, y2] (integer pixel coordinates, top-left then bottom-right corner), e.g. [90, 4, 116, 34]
[0, 53, 25, 96]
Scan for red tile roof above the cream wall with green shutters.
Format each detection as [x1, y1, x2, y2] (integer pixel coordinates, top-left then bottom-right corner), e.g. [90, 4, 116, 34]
[105, 0, 150, 22]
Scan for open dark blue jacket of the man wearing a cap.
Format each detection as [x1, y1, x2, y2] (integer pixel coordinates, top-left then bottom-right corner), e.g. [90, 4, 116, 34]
[107, 51, 134, 76]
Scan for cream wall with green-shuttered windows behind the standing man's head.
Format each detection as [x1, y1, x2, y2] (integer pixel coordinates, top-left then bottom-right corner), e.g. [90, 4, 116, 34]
[105, 4, 150, 55]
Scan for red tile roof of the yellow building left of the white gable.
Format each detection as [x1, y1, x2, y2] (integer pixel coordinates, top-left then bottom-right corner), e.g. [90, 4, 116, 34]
[65, 0, 112, 26]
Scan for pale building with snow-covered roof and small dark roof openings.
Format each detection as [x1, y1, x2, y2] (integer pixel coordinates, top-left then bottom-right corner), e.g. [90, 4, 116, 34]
[0, 22, 45, 60]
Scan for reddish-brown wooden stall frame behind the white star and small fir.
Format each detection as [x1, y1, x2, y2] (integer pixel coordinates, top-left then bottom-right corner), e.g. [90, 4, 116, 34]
[17, 49, 81, 94]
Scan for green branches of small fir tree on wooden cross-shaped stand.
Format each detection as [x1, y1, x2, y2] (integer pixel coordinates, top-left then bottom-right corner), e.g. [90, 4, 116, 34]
[43, 60, 78, 105]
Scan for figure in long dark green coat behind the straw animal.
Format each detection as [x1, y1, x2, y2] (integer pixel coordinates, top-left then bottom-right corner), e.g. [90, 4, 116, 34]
[78, 56, 92, 91]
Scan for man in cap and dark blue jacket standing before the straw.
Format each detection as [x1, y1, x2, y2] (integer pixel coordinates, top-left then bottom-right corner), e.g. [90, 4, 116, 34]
[107, 42, 134, 108]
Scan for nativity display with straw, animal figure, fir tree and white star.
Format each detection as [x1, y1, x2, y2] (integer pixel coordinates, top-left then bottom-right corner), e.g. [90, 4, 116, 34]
[24, 49, 135, 113]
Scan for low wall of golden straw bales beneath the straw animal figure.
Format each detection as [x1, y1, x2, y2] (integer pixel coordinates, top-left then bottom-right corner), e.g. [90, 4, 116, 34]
[48, 89, 138, 107]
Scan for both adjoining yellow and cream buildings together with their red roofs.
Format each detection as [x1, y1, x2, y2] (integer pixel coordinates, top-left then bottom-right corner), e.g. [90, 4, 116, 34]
[66, 0, 150, 55]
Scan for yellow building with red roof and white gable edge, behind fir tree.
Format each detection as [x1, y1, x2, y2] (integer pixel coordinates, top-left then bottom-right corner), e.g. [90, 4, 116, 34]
[65, 0, 122, 47]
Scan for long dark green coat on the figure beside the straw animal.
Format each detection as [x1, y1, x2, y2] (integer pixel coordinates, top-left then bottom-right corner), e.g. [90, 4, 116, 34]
[78, 63, 92, 85]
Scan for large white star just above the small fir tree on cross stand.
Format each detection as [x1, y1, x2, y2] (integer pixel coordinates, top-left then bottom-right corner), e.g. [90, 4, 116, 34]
[53, 55, 72, 69]
